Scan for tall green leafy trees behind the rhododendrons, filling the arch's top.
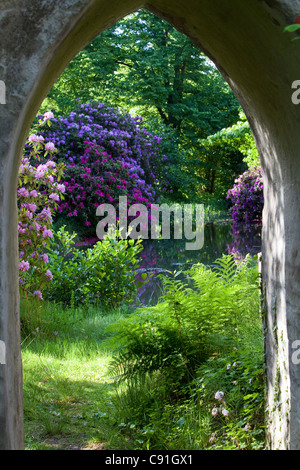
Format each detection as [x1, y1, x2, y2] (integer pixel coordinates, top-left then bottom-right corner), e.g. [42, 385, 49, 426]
[44, 9, 245, 201]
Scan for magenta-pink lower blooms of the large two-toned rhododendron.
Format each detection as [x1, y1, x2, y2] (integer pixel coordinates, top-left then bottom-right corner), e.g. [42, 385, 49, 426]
[57, 141, 153, 234]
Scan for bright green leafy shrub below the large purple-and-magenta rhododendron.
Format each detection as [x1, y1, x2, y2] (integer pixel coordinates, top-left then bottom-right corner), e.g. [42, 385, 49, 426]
[45, 227, 142, 307]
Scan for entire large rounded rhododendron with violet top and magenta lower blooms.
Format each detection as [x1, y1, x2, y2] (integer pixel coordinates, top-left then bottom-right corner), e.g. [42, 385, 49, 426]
[37, 103, 168, 233]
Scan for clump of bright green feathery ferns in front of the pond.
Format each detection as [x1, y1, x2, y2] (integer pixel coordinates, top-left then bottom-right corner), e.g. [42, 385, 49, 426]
[105, 256, 259, 388]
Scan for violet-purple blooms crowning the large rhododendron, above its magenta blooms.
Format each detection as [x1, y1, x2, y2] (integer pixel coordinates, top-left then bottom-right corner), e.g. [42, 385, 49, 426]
[38, 103, 165, 193]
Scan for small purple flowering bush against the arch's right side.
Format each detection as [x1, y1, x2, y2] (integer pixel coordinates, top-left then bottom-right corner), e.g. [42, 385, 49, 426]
[227, 167, 264, 228]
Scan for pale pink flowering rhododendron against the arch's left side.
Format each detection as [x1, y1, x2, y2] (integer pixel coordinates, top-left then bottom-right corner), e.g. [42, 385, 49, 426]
[17, 112, 65, 299]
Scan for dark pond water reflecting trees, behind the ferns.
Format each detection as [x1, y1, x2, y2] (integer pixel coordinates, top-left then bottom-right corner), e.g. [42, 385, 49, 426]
[135, 220, 261, 306]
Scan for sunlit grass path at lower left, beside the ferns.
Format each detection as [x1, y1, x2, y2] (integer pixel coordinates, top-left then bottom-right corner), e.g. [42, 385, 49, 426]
[22, 301, 134, 450]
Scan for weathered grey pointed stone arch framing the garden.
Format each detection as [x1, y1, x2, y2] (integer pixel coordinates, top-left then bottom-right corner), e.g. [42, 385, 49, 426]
[0, 0, 300, 449]
